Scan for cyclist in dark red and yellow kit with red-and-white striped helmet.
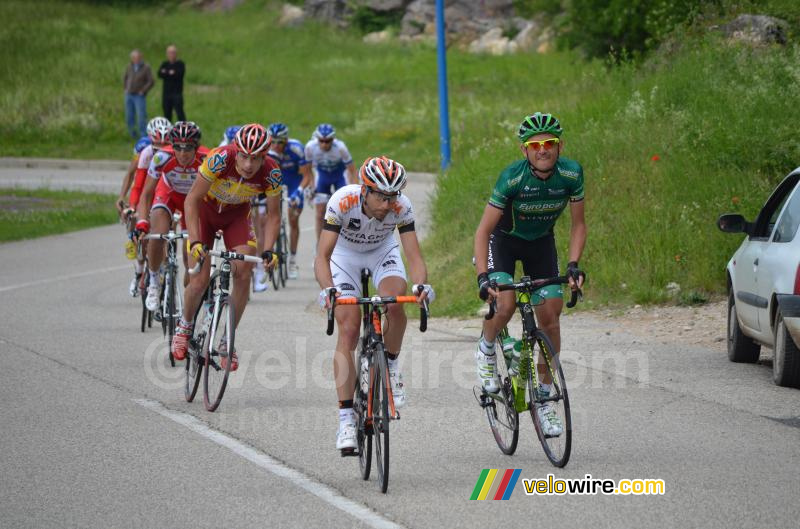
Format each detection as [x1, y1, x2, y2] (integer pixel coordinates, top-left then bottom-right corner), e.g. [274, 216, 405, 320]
[172, 123, 283, 370]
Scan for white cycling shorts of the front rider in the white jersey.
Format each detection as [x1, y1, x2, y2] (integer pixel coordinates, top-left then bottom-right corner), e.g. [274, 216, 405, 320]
[331, 241, 406, 297]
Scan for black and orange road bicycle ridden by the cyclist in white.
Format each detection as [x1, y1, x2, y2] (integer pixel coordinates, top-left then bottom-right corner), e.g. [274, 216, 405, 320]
[326, 268, 428, 493]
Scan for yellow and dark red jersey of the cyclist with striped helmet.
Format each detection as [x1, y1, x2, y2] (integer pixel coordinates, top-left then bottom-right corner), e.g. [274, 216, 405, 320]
[200, 145, 283, 206]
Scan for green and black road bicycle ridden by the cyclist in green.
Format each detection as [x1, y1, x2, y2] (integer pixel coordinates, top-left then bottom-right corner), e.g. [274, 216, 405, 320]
[473, 272, 582, 467]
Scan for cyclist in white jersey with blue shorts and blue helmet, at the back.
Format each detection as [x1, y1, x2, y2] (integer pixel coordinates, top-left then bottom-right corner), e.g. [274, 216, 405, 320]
[306, 123, 358, 240]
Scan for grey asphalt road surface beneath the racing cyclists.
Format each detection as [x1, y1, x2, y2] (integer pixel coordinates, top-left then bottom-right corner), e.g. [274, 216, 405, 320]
[0, 163, 800, 529]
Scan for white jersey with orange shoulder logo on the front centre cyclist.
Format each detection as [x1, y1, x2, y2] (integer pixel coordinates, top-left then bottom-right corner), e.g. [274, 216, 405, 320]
[323, 184, 414, 252]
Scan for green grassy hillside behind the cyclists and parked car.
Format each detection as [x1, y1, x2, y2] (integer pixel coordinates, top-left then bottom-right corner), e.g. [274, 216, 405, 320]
[0, 0, 800, 315]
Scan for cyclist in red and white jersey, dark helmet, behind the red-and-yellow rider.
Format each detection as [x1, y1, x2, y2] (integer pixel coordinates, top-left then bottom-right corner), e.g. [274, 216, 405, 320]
[136, 121, 208, 311]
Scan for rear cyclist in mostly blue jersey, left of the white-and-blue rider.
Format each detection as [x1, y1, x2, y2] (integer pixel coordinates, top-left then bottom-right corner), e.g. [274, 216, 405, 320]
[266, 123, 311, 279]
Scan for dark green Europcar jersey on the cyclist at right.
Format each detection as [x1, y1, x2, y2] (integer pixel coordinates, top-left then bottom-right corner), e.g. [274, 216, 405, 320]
[489, 158, 583, 241]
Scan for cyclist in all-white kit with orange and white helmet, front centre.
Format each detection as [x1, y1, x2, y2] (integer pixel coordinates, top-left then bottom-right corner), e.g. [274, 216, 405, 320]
[314, 156, 434, 450]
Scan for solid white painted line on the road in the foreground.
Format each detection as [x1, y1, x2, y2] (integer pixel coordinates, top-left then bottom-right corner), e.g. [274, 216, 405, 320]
[132, 399, 402, 529]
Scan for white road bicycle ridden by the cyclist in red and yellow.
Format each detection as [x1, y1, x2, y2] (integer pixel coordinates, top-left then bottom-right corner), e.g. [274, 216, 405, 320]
[184, 245, 262, 412]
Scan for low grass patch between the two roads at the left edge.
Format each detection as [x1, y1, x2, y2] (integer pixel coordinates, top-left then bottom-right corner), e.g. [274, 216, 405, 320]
[0, 189, 117, 242]
